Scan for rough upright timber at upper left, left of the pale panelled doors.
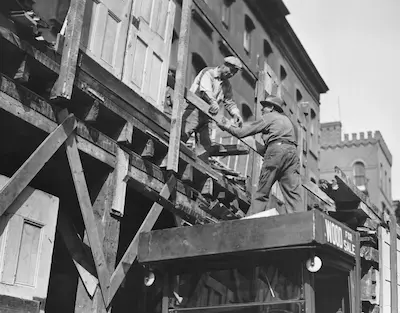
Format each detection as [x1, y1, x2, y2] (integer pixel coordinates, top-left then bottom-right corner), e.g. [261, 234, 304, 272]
[50, 0, 86, 99]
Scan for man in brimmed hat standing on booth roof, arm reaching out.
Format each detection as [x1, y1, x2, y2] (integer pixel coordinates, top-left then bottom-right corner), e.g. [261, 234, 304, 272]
[218, 96, 302, 216]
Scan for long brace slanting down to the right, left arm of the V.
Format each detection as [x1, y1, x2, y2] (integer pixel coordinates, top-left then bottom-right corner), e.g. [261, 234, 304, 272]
[58, 110, 110, 303]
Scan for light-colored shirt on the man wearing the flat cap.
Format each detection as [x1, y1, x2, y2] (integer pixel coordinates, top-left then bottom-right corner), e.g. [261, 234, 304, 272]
[190, 67, 240, 115]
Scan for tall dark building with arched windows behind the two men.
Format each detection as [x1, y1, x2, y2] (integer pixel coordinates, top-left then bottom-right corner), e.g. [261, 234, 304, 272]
[170, 0, 328, 181]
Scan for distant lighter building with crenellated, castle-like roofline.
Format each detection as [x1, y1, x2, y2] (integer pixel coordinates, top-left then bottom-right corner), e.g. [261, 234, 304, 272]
[320, 122, 393, 212]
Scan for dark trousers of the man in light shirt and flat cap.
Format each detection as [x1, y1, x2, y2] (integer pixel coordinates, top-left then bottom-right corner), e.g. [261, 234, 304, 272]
[181, 104, 213, 163]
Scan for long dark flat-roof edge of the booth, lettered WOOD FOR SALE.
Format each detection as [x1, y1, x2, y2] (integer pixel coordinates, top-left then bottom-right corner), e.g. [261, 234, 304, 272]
[138, 210, 359, 263]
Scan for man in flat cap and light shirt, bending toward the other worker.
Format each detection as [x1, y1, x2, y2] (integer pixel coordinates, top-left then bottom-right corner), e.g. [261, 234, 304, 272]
[181, 56, 243, 163]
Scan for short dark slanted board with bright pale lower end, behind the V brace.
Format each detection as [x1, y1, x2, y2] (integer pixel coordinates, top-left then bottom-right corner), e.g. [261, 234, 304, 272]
[57, 211, 99, 297]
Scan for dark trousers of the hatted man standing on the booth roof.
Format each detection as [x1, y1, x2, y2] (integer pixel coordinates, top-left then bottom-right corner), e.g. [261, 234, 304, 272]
[247, 143, 303, 216]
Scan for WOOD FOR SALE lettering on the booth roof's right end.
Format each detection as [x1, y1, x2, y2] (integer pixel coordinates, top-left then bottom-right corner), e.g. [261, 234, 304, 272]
[323, 218, 356, 256]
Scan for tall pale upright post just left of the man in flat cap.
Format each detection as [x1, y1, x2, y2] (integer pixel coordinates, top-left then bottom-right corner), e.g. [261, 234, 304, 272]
[167, 0, 193, 173]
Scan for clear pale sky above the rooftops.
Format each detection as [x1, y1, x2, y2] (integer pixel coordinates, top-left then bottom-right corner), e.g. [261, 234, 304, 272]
[284, 0, 400, 200]
